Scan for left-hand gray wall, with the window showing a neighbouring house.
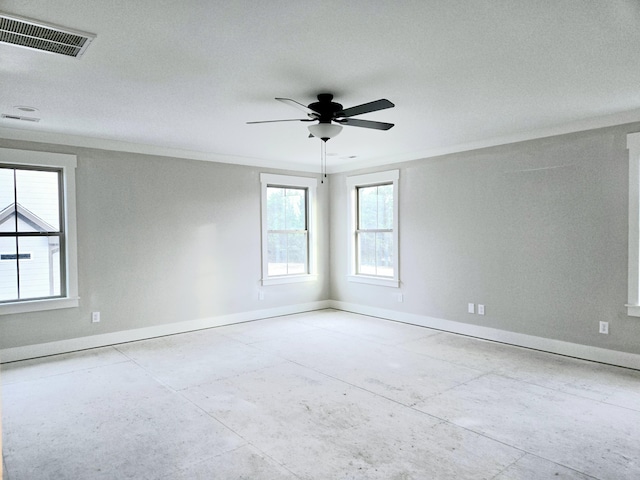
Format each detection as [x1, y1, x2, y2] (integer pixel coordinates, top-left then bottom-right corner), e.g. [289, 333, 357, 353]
[0, 140, 329, 349]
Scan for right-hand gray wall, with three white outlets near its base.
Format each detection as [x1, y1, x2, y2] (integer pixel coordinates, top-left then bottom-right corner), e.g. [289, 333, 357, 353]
[330, 125, 640, 353]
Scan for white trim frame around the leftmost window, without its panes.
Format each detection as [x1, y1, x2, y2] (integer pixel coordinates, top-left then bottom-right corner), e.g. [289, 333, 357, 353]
[0, 148, 79, 315]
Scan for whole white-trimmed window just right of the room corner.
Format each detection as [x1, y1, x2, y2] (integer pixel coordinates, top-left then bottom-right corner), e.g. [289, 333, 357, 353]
[347, 170, 399, 287]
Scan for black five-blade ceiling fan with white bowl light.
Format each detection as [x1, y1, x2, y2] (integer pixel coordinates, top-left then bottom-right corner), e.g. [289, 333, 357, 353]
[247, 93, 395, 142]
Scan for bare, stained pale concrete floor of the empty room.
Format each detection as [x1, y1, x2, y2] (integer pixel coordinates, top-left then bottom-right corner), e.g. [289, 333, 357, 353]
[1, 310, 640, 480]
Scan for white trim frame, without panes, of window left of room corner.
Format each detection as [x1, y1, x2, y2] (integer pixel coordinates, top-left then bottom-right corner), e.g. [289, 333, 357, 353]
[260, 173, 318, 285]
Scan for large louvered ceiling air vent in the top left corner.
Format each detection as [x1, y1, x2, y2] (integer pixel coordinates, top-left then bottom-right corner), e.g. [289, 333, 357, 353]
[0, 12, 96, 57]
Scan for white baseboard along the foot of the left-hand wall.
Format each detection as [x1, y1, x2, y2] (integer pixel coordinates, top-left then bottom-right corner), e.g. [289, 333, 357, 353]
[0, 300, 330, 363]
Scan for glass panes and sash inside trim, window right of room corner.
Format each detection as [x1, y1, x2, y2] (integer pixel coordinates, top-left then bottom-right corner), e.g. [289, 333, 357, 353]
[356, 183, 394, 278]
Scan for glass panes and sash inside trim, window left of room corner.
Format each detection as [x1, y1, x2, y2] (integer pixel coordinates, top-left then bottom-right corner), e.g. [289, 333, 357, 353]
[267, 185, 309, 277]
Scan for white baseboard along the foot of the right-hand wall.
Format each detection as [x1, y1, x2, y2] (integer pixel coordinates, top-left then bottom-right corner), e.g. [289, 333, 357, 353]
[329, 300, 640, 370]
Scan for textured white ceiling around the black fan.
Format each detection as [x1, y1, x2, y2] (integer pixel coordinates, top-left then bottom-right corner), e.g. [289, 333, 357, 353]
[0, 0, 640, 171]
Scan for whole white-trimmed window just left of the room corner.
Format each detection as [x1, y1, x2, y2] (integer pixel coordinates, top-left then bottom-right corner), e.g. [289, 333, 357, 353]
[260, 173, 317, 285]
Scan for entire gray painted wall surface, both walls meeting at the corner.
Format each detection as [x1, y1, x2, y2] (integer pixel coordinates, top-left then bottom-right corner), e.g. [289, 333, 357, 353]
[0, 124, 640, 353]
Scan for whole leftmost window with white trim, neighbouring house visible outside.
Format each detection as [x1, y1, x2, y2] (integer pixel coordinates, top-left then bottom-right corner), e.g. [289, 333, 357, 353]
[0, 149, 78, 314]
